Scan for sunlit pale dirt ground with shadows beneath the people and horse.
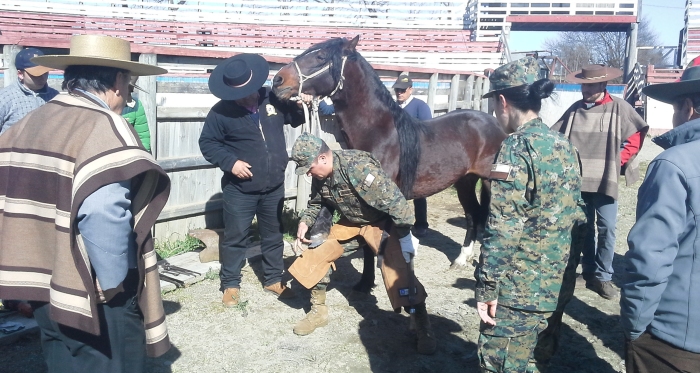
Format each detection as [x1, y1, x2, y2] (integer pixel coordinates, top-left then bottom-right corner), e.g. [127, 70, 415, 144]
[0, 142, 660, 373]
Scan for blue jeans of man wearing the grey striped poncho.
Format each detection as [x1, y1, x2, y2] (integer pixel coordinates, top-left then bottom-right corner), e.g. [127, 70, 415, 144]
[581, 192, 617, 281]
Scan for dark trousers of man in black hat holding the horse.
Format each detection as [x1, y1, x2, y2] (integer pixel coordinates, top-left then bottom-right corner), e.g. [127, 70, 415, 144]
[219, 184, 284, 291]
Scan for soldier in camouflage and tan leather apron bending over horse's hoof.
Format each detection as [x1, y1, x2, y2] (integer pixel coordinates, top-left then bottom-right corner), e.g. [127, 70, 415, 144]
[289, 134, 436, 355]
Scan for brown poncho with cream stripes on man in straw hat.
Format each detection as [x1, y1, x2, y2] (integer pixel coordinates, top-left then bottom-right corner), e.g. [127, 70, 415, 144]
[0, 91, 170, 356]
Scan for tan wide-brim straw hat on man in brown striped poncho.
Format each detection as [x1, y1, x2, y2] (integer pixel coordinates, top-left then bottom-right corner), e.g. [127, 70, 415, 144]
[31, 35, 168, 76]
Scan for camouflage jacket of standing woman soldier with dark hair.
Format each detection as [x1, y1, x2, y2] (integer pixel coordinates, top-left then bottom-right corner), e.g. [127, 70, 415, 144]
[475, 118, 585, 312]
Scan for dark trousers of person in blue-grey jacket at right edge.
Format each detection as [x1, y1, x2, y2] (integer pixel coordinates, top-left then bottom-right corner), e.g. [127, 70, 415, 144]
[625, 332, 700, 373]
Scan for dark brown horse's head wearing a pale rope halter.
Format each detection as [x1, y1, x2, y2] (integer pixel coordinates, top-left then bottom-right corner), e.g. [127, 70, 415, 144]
[272, 35, 360, 100]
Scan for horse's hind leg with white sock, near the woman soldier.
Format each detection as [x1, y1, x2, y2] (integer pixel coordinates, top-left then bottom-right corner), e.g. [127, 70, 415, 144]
[450, 175, 481, 269]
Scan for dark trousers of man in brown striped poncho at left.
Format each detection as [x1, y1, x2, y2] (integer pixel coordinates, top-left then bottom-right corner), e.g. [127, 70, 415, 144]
[32, 291, 146, 373]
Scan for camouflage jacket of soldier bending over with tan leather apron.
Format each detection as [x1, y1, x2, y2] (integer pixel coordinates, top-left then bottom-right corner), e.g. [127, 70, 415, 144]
[301, 150, 415, 237]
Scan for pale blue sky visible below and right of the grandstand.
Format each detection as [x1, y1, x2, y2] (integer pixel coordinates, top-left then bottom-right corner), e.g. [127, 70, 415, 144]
[509, 0, 685, 52]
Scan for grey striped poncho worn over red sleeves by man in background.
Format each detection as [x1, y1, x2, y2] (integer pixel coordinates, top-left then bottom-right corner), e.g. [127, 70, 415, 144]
[551, 96, 649, 199]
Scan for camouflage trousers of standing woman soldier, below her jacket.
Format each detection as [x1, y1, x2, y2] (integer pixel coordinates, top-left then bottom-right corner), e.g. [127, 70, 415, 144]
[478, 305, 552, 373]
